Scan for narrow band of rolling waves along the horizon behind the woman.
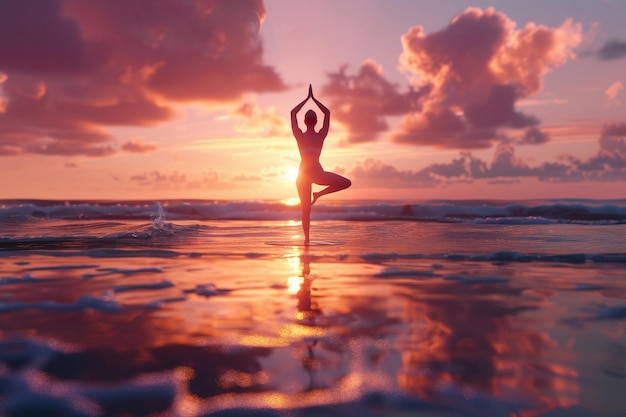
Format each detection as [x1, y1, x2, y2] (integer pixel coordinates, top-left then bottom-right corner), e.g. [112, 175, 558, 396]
[0, 199, 626, 224]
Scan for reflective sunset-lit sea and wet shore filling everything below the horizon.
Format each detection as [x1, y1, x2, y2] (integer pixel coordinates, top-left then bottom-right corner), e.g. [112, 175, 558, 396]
[0, 199, 626, 417]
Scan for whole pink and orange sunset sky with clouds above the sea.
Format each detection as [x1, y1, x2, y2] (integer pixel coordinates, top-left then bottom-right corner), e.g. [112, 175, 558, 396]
[0, 0, 626, 200]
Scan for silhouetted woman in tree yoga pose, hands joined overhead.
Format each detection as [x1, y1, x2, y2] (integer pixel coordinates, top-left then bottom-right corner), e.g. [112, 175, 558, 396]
[291, 84, 352, 244]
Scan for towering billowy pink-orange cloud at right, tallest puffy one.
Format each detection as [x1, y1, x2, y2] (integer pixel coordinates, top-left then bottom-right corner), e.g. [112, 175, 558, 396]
[392, 8, 582, 149]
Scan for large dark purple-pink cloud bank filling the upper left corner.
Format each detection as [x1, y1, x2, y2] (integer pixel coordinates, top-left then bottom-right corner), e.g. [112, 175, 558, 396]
[0, 0, 285, 156]
